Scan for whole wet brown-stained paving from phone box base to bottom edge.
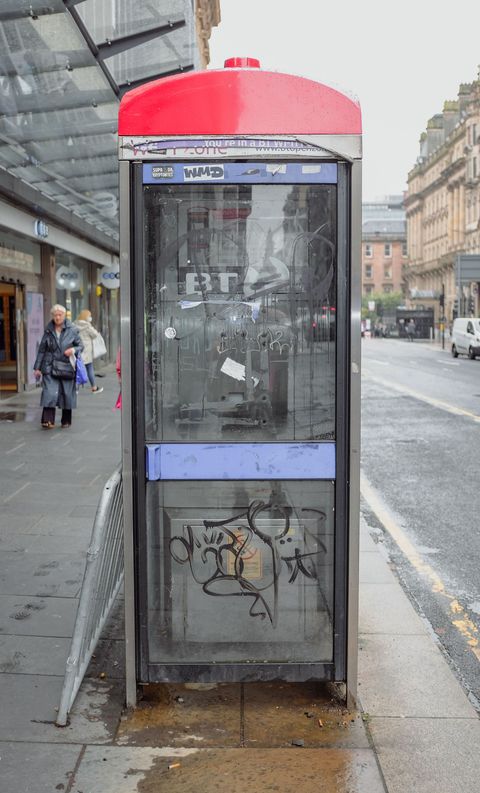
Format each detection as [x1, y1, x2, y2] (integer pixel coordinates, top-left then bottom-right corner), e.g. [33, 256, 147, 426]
[112, 683, 385, 793]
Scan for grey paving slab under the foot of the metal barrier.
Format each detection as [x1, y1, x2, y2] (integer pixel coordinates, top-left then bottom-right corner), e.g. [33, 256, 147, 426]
[0, 674, 124, 744]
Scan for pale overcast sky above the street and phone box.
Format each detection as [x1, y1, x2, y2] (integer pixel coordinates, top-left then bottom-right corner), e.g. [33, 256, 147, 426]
[209, 0, 480, 200]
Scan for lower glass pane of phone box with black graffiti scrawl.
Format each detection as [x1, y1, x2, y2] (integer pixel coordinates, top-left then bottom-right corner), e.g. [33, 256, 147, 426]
[147, 481, 334, 663]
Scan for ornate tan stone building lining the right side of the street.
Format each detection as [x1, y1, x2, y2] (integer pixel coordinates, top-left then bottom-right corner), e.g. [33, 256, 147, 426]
[405, 72, 480, 324]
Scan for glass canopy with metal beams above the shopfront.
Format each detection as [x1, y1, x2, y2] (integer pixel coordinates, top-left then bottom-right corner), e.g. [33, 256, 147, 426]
[0, 0, 198, 241]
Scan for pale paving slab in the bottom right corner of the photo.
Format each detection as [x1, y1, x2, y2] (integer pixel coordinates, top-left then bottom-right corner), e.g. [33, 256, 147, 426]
[369, 718, 480, 793]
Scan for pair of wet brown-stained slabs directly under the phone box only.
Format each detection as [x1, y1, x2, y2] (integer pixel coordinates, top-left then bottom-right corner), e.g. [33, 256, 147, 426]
[117, 682, 369, 749]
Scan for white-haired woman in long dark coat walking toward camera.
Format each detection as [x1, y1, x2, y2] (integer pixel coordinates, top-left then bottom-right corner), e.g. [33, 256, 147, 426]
[33, 303, 83, 430]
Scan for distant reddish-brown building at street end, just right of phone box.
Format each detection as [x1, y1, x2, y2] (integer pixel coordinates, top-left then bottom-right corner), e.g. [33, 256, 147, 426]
[362, 195, 407, 296]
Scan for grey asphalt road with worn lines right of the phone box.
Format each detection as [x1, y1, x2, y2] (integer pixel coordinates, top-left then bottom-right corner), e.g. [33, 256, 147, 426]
[362, 339, 480, 711]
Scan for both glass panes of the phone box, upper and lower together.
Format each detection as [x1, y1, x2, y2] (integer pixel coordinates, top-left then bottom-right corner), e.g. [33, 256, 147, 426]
[144, 178, 336, 663]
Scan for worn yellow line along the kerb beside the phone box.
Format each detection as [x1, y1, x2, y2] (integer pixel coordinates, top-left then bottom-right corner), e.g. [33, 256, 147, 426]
[360, 472, 480, 661]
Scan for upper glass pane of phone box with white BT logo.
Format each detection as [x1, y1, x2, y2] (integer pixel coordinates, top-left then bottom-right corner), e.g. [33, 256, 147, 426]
[144, 179, 336, 441]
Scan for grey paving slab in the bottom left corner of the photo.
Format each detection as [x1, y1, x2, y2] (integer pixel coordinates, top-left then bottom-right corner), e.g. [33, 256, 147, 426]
[0, 741, 81, 793]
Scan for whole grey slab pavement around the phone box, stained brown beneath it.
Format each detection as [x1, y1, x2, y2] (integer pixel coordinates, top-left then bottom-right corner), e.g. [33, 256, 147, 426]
[0, 367, 480, 793]
